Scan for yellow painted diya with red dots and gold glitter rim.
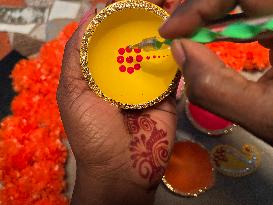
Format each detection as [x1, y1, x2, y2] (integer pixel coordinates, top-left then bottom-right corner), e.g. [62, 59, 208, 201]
[80, 0, 180, 109]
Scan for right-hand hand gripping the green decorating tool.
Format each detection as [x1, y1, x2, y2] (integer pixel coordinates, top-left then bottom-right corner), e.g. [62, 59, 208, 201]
[159, 0, 273, 142]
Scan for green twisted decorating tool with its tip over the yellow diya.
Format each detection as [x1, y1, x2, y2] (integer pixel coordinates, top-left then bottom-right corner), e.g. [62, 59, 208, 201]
[129, 13, 273, 51]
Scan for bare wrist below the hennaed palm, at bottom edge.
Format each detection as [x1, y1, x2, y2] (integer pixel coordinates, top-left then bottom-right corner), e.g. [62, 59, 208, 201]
[71, 167, 155, 205]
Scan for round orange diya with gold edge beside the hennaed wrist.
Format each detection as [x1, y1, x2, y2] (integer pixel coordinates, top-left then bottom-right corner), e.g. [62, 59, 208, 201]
[162, 141, 214, 196]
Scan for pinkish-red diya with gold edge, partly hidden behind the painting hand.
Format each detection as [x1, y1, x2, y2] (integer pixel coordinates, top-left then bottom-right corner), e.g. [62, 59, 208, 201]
[185, 100, 235, 136]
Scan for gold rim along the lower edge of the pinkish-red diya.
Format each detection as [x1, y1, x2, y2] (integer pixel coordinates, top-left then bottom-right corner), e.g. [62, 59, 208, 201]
[185, 99, 237, 136]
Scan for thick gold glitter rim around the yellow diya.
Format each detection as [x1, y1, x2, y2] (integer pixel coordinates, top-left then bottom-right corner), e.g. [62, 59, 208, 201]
[80, 0, 181, 109]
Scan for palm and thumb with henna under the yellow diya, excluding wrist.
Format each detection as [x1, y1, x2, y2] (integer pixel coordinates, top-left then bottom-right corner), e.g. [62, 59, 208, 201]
[57, 22, 176, 186]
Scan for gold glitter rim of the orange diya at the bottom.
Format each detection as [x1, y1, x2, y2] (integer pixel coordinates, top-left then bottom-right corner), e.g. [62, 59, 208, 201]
[161, 139, 216, 198]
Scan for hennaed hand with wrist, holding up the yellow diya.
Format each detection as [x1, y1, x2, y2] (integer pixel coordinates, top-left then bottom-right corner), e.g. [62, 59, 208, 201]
[57, 4, 176, 205]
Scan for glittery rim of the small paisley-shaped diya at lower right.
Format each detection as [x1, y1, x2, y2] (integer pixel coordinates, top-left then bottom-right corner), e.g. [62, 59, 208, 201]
[210, 144, 261, 178]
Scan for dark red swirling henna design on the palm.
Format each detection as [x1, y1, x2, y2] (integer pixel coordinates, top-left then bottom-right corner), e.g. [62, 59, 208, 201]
[126, 114, 169, 184]
